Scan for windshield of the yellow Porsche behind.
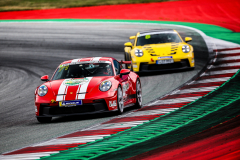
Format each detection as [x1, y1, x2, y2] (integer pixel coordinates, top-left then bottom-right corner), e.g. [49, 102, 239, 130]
[137, 33, 181, 46]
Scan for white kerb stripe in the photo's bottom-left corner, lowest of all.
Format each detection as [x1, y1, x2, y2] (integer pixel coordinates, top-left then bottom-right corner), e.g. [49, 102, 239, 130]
[0, 151, 59, 160]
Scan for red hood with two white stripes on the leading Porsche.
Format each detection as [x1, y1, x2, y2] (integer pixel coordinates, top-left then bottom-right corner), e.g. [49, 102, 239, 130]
[49, 76, 111, 101]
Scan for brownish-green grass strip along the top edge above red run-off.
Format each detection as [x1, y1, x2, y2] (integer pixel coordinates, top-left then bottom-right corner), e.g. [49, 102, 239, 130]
[0, 0, 173, 11]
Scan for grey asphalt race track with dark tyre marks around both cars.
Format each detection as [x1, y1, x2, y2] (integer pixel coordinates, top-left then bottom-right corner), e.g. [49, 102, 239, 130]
[0, 22, 208, 153]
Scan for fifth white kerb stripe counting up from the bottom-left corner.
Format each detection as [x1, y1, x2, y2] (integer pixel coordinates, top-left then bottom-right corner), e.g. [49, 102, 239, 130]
[148, 96, 202, 106]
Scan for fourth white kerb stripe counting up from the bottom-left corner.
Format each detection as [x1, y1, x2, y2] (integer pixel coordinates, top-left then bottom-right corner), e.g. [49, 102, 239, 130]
[124, 108, 179, 117]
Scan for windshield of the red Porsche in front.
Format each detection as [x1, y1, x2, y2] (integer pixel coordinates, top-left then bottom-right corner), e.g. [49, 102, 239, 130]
[52, 61, 114, 80]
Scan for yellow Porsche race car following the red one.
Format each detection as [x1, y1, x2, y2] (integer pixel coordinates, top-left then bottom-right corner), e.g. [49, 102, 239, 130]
[124, 29, 195, 72]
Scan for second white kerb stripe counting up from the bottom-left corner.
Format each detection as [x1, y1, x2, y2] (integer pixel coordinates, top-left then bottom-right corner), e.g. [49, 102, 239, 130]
[34, 134, 110, 146]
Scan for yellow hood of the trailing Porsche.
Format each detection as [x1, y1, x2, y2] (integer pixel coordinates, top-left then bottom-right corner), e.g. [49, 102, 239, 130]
[136, 43, 182, 56]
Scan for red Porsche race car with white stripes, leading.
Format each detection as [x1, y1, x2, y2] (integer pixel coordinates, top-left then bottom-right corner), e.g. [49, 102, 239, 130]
[35, 57, 142, 123]
